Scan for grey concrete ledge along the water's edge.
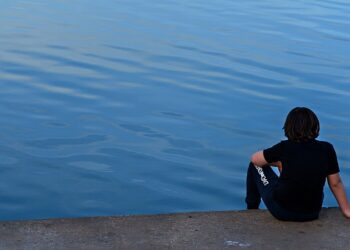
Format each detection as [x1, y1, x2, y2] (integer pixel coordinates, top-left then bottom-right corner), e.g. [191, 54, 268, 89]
[0, 208, 350, 250]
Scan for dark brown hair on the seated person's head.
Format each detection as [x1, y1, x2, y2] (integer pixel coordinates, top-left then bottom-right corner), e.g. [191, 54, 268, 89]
[283, 107, 320, 142]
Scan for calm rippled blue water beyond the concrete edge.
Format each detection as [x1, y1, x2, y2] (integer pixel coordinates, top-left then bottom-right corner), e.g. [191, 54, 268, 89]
[0, 0, 350, 220]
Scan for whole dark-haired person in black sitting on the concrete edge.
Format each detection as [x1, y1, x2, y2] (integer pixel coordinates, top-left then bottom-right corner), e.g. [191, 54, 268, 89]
[245, 107, 350, 221]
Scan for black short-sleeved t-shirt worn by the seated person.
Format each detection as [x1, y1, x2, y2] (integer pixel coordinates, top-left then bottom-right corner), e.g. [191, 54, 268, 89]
[263, 140, 339, 212]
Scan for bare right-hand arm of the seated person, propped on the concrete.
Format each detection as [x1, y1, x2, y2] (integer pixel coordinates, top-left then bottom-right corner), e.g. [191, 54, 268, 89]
[327, 173, 350, 218]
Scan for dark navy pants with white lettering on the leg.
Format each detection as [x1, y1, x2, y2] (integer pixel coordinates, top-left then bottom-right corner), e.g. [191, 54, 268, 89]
[245, 163, 319, 221]
